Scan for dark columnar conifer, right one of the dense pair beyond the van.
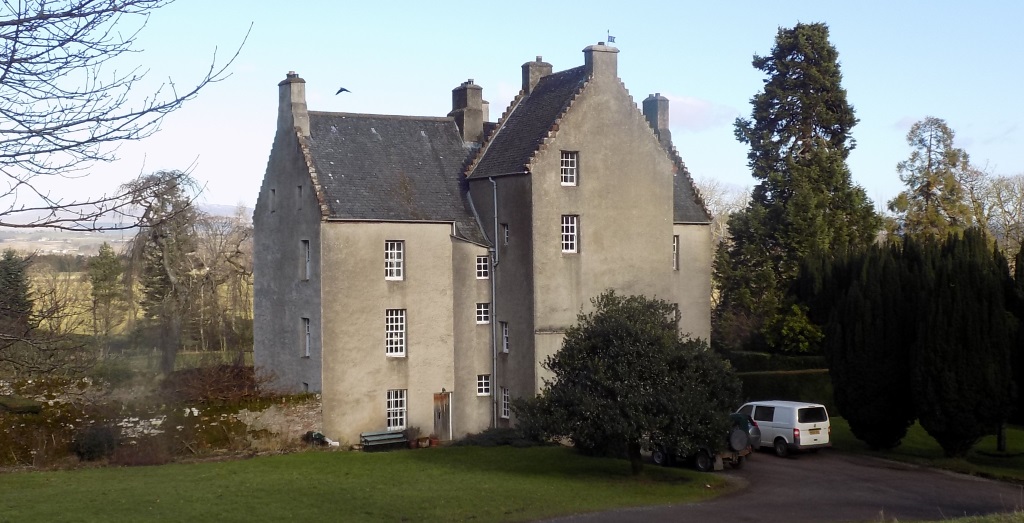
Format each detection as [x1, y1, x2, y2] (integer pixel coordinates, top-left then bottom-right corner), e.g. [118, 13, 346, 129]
[911, 228, 1013, 456]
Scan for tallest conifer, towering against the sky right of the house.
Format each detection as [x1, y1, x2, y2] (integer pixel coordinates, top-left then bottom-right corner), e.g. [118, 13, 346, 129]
[714, 24, 881, 348]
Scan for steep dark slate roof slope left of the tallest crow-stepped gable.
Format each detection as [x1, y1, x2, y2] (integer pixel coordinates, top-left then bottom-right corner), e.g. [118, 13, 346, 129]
[470, 66, 587, 178]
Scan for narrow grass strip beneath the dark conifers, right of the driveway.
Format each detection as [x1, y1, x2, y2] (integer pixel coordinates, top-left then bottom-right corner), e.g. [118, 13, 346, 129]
[831, 417, 1024, 483]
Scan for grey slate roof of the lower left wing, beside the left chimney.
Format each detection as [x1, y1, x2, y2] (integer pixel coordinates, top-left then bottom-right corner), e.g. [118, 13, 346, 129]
[308, 111, 486, 244]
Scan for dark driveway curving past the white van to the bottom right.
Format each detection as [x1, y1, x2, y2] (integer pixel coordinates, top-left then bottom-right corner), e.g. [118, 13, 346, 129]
[551, 450, 1024, 523]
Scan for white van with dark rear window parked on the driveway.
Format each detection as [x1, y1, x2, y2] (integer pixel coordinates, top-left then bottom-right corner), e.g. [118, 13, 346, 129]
[737, 401, 831, 456]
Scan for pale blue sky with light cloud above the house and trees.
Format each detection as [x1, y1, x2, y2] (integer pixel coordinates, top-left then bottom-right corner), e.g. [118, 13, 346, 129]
[36, 0, 1024, 215]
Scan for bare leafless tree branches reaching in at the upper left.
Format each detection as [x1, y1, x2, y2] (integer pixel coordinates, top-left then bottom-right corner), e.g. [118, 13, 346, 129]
[0, 0, 248, 230]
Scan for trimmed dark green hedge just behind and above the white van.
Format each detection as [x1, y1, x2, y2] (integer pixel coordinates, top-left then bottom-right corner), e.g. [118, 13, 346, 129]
[736, 368, 840, 416]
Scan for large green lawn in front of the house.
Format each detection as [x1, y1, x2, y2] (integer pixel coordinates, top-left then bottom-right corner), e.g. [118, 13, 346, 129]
[0, 447, 732, 522]
